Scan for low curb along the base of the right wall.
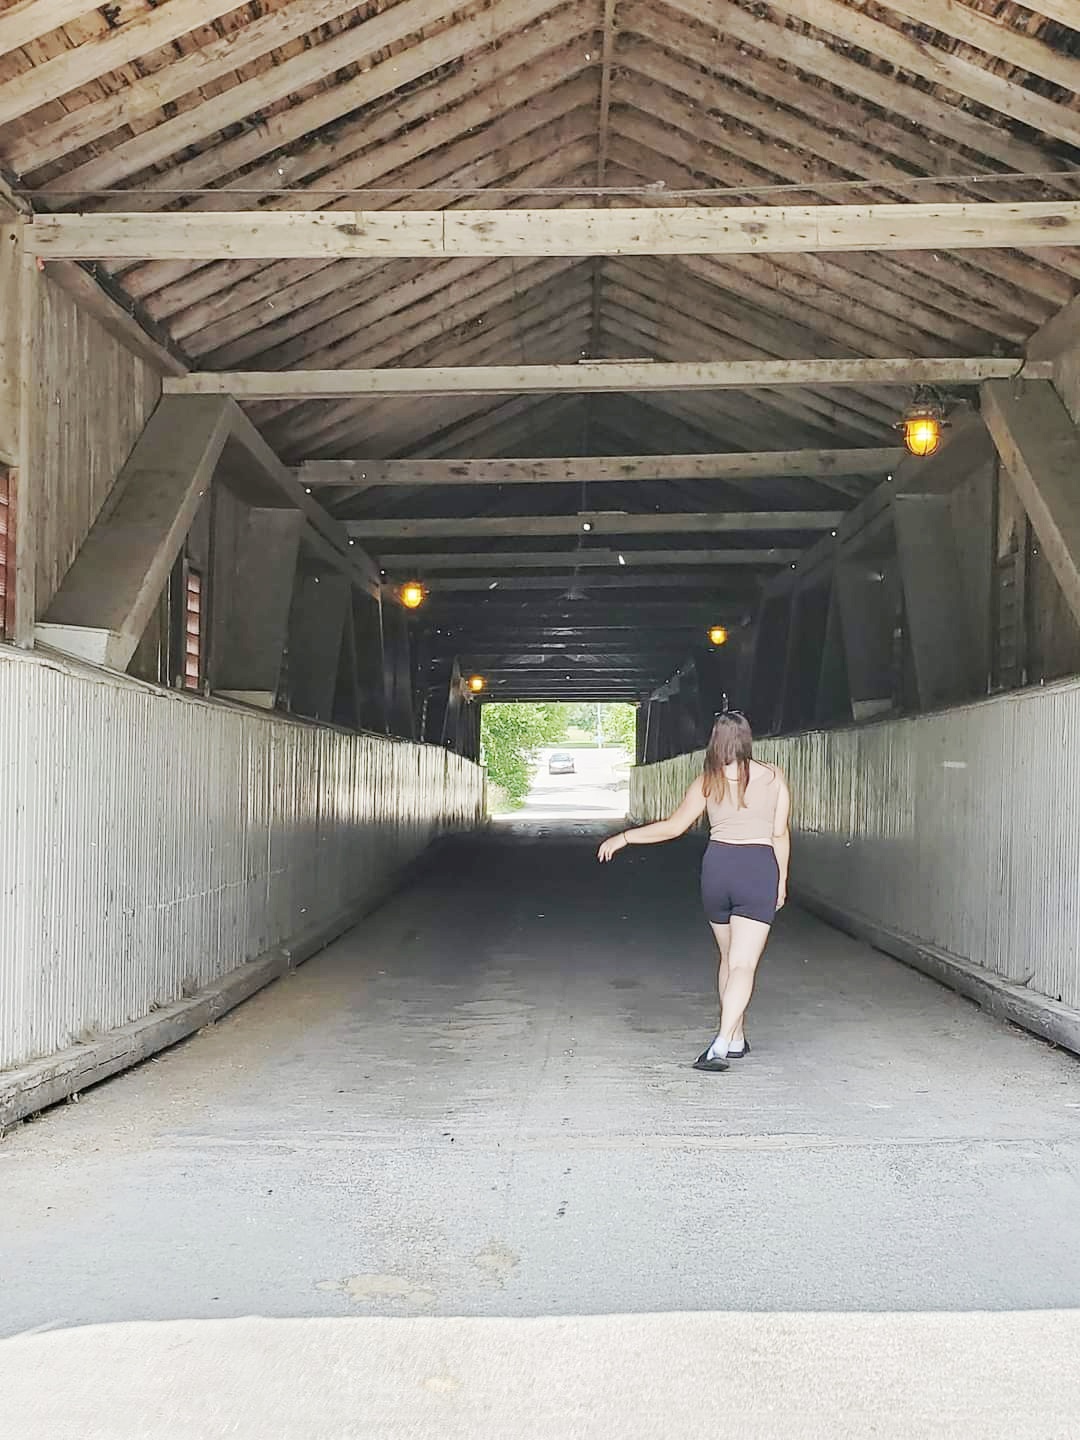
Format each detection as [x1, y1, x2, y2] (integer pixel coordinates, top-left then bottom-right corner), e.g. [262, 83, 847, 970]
[792, 888, 1080, 1056]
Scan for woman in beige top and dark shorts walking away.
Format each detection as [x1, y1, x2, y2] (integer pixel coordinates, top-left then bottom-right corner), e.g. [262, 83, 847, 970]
[596, 710, 791, 1070]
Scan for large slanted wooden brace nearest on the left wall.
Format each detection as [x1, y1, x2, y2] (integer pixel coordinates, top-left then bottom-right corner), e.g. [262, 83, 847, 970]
[36, 396, 232, 670]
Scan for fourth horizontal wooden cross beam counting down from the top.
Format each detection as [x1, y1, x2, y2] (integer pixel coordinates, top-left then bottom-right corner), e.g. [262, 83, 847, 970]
[351, 510, 844, 541]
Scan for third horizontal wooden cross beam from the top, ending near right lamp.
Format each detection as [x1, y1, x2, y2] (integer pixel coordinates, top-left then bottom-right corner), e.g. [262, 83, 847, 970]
[297, 448, 906, 490]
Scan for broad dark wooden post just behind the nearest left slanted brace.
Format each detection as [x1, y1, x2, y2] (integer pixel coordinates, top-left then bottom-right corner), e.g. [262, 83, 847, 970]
[209, 506, 305, 710]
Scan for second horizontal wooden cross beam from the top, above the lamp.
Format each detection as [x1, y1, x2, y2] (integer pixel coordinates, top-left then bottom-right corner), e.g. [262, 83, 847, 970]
[163, 356, 1051, 402]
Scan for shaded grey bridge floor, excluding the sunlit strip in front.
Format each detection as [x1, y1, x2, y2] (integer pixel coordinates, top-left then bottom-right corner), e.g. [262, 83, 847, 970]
[0, 824, 1080, 1436]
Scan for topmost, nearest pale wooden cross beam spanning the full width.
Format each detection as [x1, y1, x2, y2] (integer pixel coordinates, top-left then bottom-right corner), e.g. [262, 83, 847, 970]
[27, 204, 1080, 261]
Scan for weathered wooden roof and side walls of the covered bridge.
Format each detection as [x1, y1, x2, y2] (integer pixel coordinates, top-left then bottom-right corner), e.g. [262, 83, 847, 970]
[0, 0, 1080, 1416]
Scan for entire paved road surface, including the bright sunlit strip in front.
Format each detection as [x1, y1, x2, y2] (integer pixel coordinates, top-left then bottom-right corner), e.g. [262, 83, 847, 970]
[0, 821, 1080, 1440]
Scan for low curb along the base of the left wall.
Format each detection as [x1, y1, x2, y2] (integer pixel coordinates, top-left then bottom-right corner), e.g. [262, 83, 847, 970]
[0, 837, 442, 1136]
